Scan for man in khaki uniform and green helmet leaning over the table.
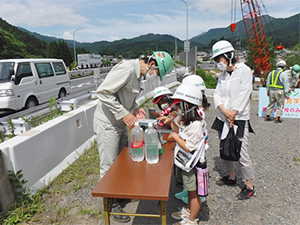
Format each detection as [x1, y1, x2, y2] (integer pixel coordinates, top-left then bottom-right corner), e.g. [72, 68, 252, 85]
[94, 51, 173, 222]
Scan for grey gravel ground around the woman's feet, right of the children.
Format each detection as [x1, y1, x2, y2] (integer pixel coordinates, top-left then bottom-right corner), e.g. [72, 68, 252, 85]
[199, 99, 300, 224]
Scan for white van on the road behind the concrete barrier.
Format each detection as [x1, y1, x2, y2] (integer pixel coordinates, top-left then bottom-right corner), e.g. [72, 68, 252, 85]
[0, 59, 71, 110]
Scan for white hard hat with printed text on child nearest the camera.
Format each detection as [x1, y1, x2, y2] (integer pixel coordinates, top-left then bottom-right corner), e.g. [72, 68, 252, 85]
[171, 84, 202, 105]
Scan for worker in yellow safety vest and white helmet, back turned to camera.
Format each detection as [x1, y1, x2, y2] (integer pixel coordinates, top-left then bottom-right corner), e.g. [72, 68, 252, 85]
[265, 60, 289, 123]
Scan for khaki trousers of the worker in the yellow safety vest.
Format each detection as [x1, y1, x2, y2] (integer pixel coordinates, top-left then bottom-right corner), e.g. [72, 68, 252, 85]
[266, 89, 285, 117]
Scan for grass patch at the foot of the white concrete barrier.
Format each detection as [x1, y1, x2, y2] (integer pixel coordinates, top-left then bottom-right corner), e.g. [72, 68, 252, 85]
[0, 141, 102, 225]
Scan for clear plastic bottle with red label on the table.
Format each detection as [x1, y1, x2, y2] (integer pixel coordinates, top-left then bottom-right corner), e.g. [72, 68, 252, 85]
[130, 122, 144, 162]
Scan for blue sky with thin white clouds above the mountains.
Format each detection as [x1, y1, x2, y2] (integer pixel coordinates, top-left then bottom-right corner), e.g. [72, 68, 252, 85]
[0, 0, 300, 42]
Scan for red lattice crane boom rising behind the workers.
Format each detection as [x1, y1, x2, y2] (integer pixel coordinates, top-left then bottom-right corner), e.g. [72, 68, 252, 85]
[240, 0, 271, 80]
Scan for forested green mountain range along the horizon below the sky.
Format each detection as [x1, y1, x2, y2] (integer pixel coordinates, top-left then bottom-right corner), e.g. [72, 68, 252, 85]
[0, 13, 300, 59]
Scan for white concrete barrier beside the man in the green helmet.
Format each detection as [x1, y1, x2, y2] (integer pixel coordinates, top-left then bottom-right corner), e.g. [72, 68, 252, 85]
[0, 101, 97, 192]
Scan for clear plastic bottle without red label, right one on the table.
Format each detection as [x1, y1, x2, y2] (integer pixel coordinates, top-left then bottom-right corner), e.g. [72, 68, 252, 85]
[145, 123, 159, 164]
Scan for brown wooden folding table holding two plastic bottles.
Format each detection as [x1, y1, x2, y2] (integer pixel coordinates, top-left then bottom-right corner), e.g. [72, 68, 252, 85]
[92, 142, 175, 225]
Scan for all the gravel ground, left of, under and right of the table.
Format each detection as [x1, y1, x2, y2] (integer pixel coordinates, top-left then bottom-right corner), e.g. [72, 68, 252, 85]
[29, 98, 300, 225]
